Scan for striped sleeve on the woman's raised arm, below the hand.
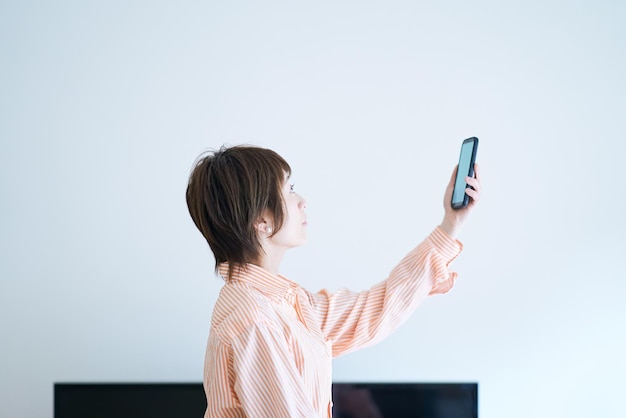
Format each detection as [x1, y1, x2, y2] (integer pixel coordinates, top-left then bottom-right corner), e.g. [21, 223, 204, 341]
[313, 227, 463, 357]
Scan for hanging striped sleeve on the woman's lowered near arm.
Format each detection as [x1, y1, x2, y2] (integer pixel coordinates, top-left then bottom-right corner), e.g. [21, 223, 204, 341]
[232, 324, 318, 418]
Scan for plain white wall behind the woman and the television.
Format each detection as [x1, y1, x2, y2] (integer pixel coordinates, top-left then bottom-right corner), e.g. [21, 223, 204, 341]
[0, 1, 626, 418]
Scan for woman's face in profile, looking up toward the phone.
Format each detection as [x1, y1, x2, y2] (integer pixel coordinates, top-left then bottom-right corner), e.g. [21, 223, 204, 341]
[270, 178, 307, 248]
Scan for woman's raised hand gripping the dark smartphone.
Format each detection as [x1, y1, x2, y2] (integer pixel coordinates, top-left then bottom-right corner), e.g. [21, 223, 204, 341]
[441, 164, 481, 238]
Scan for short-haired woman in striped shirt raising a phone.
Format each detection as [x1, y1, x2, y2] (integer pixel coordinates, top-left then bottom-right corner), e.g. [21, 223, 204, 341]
[187, 146, 480, 418]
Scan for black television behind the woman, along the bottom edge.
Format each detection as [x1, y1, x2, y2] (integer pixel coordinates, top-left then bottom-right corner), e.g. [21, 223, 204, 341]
[54, 382, 478, 418]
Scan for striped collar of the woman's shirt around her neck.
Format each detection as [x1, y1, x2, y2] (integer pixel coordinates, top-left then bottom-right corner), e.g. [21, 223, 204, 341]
[219, 263, 299, 299]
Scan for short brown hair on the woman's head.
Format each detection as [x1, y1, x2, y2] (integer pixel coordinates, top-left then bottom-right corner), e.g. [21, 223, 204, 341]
[187, 145, 291, 279]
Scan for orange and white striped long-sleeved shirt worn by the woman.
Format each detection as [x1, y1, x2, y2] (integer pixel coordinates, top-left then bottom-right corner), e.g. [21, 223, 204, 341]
[204, 227, 462, 418]
